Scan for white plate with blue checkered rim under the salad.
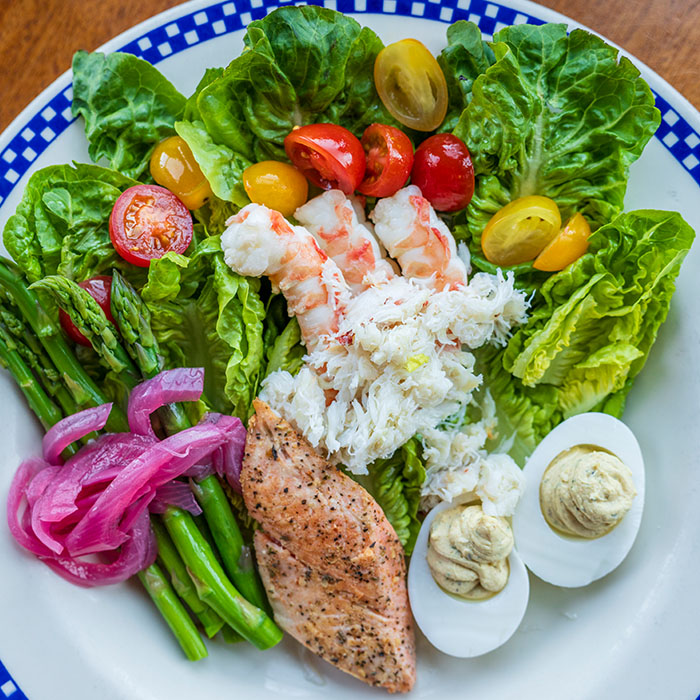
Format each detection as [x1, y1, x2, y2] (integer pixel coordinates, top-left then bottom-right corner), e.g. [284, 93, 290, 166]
[0, 0, 700, 700]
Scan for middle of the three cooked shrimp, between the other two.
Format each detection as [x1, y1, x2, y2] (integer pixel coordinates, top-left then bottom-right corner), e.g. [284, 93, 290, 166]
[294, 190, 394, 294]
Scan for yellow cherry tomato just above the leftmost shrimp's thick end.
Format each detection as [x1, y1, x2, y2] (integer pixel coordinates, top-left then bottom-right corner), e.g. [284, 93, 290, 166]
[243, 160, 309, 216]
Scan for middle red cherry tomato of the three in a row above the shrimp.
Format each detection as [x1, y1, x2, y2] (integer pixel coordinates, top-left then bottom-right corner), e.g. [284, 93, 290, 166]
[357, 124, 413, 197]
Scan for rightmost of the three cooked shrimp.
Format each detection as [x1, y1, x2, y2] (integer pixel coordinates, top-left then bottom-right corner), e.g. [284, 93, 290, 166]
[370, 185, 467, 291]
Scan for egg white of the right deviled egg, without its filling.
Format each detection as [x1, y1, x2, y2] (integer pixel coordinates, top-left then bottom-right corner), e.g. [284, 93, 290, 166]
[513, 413, 644, 588]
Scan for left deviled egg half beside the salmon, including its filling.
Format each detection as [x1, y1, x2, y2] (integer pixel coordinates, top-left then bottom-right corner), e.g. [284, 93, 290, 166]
[408, 503, 530, 657]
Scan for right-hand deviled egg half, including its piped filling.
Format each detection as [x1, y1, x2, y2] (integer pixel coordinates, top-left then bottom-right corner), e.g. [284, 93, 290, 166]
[513, 413, 644, 588]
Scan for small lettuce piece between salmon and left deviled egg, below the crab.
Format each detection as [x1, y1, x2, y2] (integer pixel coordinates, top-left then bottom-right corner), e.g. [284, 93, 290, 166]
[360, 437, 425, 555]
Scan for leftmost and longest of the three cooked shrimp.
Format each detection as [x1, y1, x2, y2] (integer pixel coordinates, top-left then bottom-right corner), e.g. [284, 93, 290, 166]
[221, 204, 351, 351]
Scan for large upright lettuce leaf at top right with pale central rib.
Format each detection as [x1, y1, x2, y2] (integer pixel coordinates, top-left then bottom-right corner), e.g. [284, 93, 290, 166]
[454, 24, 660, 250]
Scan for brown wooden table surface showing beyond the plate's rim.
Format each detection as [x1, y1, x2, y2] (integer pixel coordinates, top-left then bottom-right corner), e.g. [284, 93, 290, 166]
[0, 0, 700, 131]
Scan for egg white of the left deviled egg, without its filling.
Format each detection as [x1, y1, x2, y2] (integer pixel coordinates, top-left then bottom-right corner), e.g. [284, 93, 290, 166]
[408, 503, 530, 658]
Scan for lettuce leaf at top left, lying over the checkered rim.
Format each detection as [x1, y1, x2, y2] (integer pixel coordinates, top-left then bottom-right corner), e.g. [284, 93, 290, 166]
[72, 51, 186, 178]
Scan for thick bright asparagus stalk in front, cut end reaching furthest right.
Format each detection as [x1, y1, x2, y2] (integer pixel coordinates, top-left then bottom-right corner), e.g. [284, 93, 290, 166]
[163, 508, 282, 649]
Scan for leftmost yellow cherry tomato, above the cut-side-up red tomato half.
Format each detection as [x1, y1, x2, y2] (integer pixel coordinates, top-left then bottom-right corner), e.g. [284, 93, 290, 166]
[150, 136, 212, 209]
